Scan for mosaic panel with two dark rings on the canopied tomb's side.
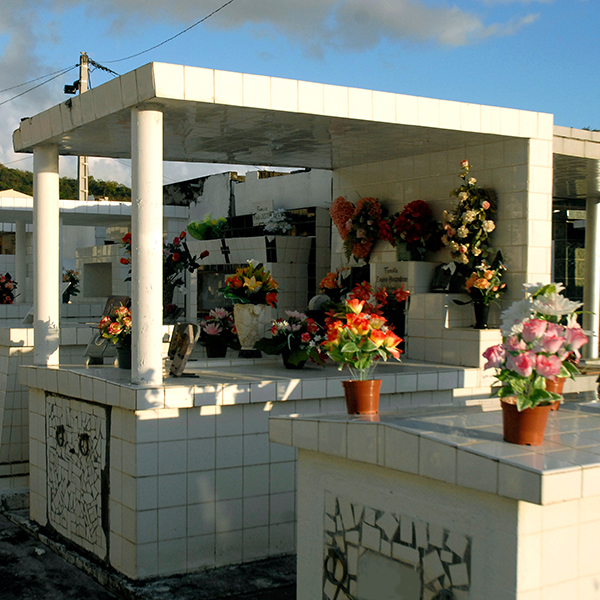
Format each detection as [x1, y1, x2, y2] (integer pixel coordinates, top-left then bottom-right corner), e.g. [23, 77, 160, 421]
[46, 394, 108, 558]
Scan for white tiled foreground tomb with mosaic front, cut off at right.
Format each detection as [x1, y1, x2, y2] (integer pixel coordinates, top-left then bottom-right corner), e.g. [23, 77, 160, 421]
[270, 402, 600, 600]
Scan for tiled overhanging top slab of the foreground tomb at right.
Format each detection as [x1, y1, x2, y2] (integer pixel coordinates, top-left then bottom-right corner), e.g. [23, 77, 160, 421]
[269, 402, 600, 505]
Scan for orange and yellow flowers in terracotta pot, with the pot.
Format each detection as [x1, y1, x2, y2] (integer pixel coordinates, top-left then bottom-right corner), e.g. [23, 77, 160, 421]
[322, 298, 402, 414]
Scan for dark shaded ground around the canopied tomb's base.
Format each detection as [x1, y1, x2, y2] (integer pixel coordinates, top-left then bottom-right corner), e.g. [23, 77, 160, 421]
[0, 510, 296, 600]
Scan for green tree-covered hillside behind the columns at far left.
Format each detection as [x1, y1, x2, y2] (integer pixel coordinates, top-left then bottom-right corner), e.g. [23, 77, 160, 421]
[0, 163, 131, 200]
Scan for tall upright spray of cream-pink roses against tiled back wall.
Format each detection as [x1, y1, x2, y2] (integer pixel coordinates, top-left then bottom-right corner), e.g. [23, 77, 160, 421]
[442, 160, 496, 269]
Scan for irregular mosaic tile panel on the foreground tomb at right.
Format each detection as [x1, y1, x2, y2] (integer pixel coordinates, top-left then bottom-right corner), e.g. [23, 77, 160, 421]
[323, 493, 471, 600]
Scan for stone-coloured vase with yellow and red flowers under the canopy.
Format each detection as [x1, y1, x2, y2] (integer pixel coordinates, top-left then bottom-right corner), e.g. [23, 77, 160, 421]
[219, 260, 277, 358]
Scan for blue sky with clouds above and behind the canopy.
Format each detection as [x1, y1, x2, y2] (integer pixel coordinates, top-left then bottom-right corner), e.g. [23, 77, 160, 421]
[0, 0, 600, 185]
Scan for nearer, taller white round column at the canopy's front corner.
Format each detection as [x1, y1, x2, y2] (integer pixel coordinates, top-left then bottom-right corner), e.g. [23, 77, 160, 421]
[131, 106, 163, 385]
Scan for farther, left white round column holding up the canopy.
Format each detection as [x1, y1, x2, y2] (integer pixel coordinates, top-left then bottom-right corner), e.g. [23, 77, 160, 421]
[33, 145, 60, 366]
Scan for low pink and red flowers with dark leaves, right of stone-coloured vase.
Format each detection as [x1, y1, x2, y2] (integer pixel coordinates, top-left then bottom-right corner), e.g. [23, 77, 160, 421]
[256, 310, 323, 369]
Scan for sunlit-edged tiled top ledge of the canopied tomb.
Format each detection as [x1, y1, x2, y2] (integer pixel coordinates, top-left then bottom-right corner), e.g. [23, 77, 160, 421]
[19, 358, 478, 410]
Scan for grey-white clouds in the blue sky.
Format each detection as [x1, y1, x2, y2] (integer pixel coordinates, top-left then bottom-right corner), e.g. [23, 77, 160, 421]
[0, 0, 545, 184]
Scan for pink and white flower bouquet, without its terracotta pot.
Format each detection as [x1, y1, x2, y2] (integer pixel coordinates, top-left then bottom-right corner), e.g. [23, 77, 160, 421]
[483, 283, 588, 411]
